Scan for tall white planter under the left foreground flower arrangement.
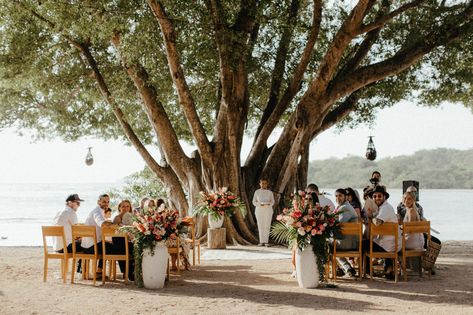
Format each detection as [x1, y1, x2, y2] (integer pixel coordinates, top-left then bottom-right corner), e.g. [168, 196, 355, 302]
[141, 243, 169, 289]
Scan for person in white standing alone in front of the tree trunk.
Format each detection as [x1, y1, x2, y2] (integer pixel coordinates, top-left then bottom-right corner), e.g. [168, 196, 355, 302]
[253, 179, 274, 246]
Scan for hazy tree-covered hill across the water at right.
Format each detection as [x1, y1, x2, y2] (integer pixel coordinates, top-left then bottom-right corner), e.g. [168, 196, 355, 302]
[308, 149, 473, 189]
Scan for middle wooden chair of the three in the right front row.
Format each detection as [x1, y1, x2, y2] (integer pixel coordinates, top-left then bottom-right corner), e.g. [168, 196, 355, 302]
[363, 222, 399, 283]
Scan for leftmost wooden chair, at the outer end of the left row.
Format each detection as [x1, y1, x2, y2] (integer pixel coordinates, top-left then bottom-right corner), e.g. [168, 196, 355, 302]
[41, 226, 74, 283]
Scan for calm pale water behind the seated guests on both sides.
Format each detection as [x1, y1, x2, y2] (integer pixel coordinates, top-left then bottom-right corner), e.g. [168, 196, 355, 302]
[0, 183, 473, 246]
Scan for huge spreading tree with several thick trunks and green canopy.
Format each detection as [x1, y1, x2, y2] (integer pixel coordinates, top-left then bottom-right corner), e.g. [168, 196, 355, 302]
[0, 0, 473, 243]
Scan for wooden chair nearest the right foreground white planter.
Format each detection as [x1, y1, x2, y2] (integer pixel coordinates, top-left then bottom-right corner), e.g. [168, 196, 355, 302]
[332, 222, 363, 281]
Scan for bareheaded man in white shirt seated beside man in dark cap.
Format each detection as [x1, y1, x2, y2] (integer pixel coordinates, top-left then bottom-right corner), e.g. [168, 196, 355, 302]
[82, 194, 113, 273]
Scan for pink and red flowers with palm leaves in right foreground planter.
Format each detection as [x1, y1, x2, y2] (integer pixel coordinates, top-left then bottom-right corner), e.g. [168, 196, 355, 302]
[271, 191, 340, 282]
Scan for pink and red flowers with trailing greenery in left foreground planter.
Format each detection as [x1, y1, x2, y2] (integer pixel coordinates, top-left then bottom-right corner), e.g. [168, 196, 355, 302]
[120, 208, 186, 287]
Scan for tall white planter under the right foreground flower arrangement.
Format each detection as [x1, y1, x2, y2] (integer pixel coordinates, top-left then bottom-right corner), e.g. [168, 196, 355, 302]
[296, 245, 319, 289]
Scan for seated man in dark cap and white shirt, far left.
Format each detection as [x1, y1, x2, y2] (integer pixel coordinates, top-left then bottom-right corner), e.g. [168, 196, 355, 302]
[53, 194, 84, 272]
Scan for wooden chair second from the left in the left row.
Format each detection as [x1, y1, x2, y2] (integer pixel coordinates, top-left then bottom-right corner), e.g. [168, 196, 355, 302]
[71, 225, 101, 285]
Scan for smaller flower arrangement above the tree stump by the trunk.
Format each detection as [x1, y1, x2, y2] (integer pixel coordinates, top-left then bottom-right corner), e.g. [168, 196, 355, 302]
[194, 187, 246, 220]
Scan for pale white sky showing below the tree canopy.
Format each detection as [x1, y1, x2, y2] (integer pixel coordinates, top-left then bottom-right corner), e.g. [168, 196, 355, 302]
[0, 102, 473, 183]
